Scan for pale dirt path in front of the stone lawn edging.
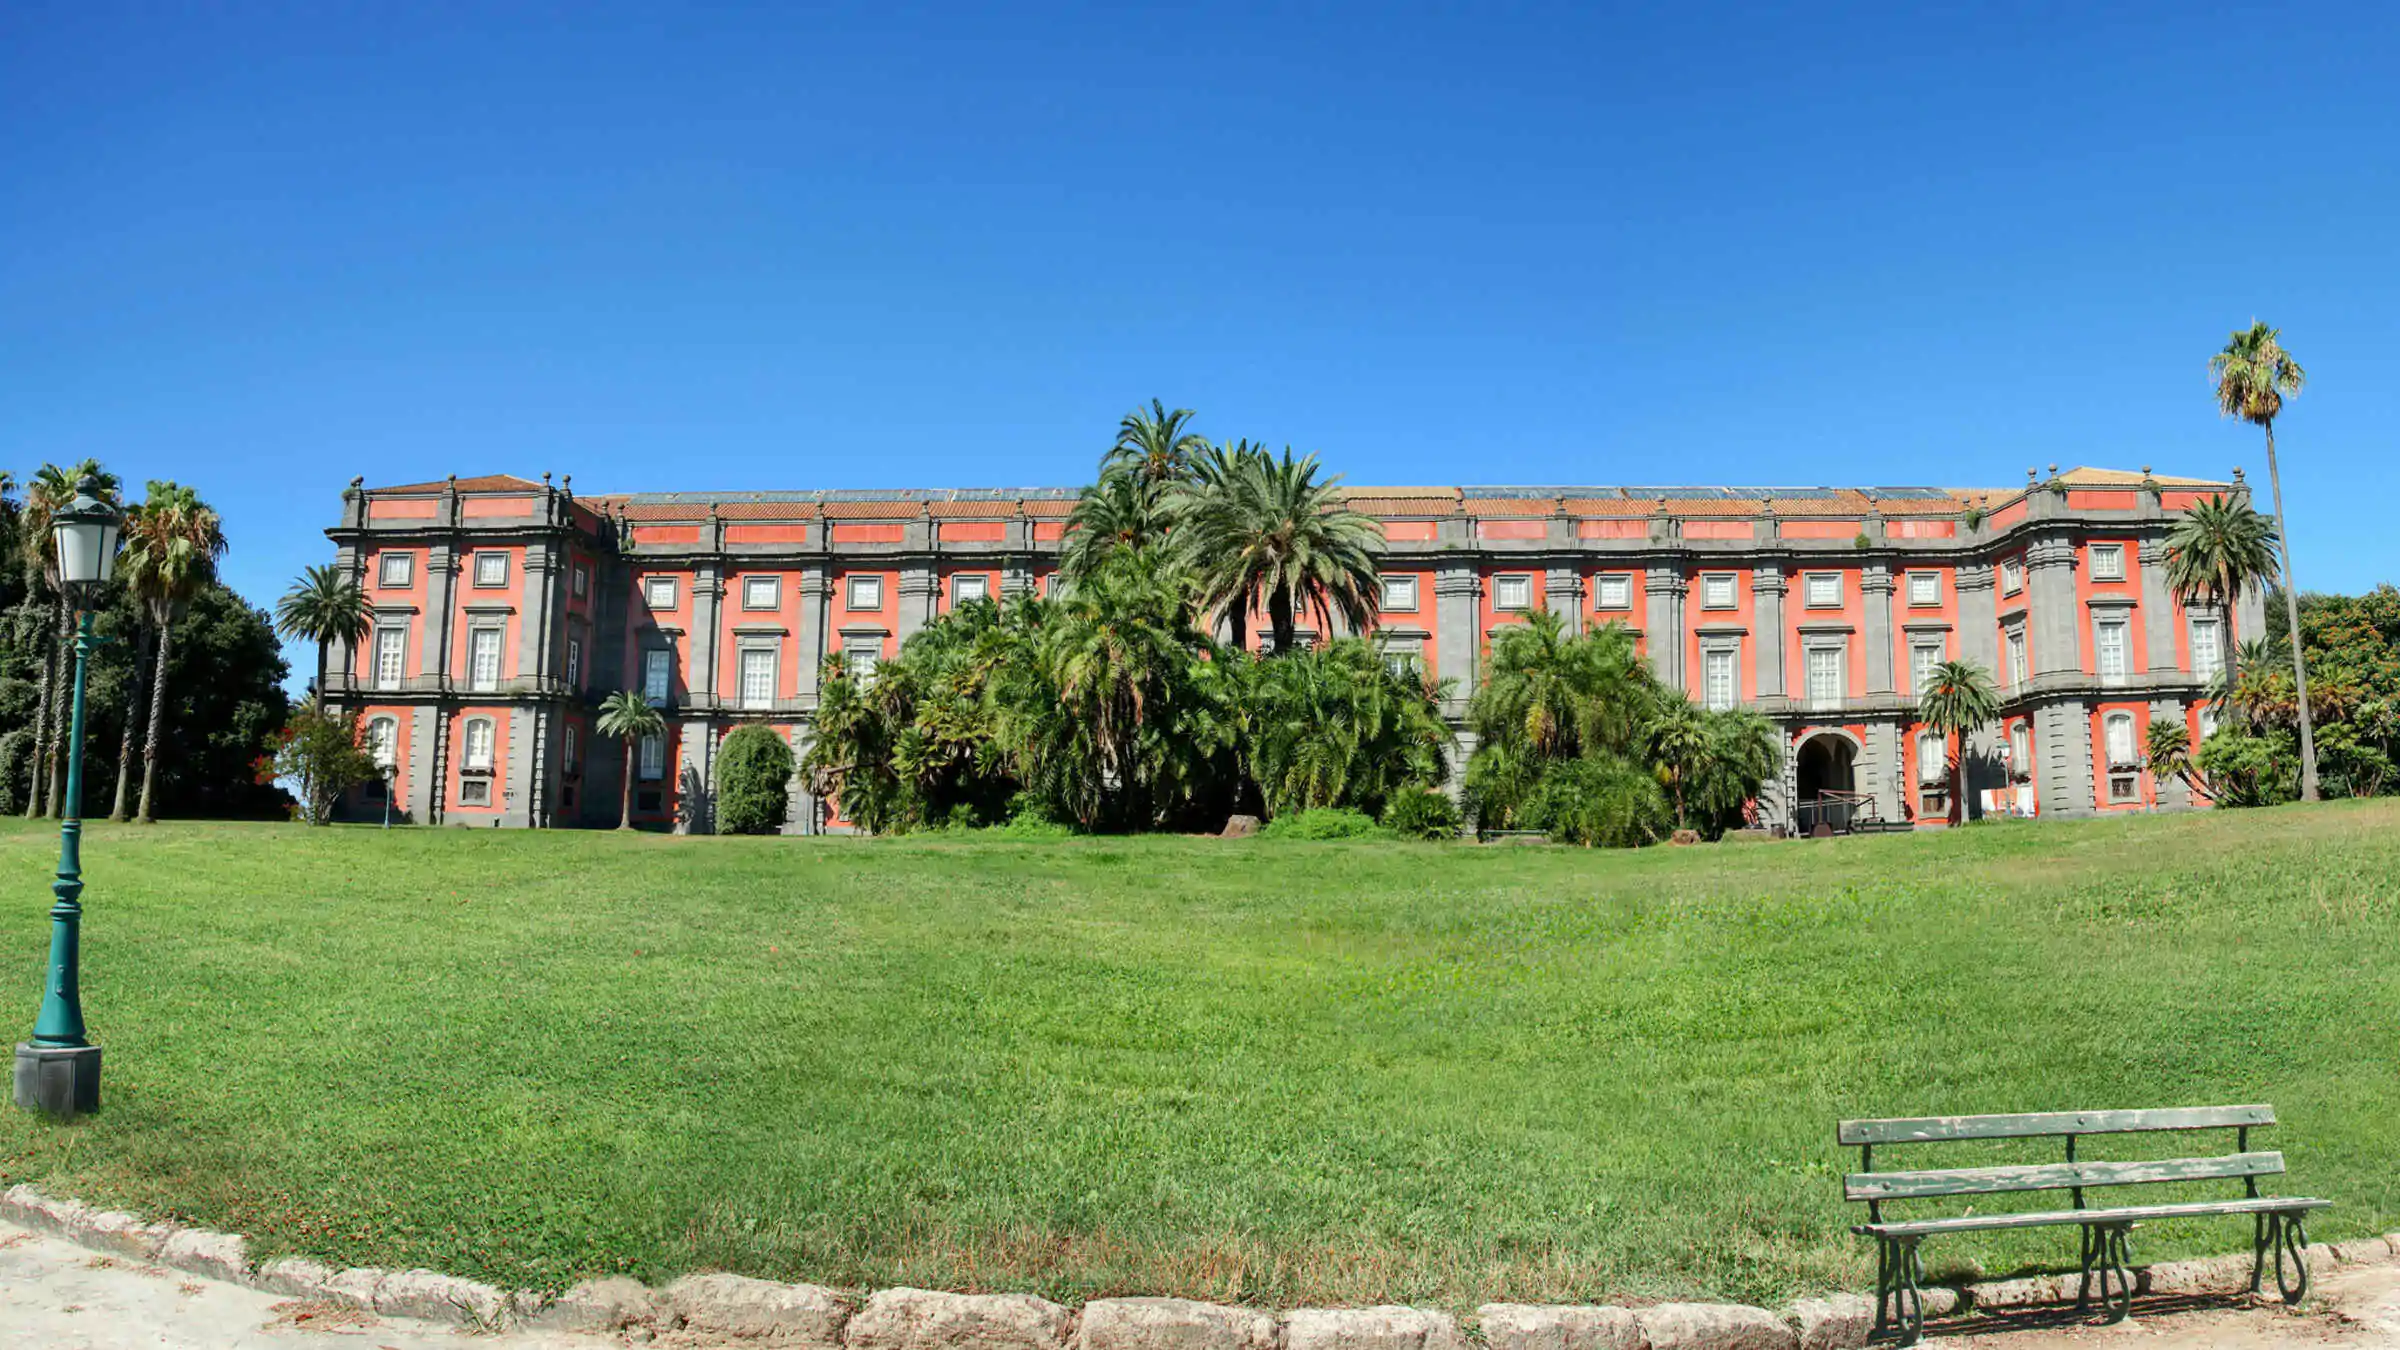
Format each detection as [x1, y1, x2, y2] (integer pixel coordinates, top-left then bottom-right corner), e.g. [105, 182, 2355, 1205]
[0, 1223, 2400, 1350]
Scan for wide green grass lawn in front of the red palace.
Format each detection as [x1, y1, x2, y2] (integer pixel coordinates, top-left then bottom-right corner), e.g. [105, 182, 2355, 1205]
[0, 802, 2400, 1307]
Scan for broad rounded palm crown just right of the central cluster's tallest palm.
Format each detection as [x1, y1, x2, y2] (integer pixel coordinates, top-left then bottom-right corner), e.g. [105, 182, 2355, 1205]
[1176, 449, 1382, 651]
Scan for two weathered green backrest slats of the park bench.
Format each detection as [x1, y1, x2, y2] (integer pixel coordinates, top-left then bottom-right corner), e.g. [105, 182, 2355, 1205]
[1836, 1105, 2282, 1223]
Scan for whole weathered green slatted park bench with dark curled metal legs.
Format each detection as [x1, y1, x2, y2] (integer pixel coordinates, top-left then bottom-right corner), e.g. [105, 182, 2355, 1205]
[1838, 1105, 2333, 1345]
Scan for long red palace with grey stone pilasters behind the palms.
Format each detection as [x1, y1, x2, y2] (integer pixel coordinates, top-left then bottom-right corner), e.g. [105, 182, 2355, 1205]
[324, 468, 2261, 834]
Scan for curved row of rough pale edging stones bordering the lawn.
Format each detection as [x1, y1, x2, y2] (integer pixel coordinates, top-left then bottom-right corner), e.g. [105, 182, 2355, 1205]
[0, 1187, 2400, 1350]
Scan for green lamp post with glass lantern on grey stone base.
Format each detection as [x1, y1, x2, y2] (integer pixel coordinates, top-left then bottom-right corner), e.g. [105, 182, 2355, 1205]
[14, 473, 122, 1119]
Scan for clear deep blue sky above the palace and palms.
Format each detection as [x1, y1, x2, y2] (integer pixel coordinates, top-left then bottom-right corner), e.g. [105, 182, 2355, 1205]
[0, 2, 2400, 667]
